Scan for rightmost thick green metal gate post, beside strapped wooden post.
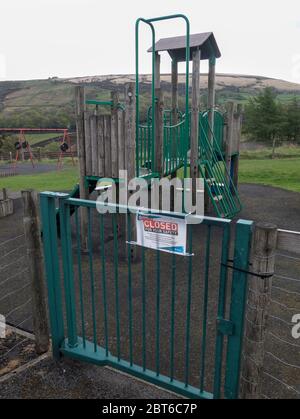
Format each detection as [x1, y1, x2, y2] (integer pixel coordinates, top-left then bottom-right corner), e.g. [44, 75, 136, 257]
[225, 220, 253, 399]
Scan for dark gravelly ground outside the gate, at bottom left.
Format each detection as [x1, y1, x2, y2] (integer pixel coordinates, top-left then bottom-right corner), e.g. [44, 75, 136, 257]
[0, 359, 176, 400]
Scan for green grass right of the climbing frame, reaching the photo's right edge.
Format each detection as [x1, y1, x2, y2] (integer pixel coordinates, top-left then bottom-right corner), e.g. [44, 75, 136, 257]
[239, 157, 300, 192]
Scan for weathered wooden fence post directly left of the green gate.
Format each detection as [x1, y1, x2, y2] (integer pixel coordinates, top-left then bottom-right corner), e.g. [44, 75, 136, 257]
[22, 190, 49, 354]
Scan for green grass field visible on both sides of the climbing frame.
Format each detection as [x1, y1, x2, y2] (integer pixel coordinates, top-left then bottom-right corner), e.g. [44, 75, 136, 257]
[0, 156, 300, 192]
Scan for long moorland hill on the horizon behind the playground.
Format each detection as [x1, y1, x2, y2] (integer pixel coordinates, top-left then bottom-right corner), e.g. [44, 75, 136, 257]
[0, 74, 300, 128]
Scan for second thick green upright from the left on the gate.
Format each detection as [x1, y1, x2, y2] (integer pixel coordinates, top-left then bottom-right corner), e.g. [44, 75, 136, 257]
[58, 194, 77, 347]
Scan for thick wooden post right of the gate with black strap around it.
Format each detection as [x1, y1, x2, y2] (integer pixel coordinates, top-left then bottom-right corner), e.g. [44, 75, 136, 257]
[241, 224, 277, 399]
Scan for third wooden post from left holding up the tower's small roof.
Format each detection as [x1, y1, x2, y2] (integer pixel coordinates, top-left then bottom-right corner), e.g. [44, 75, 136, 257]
[191, 48, 201, 201]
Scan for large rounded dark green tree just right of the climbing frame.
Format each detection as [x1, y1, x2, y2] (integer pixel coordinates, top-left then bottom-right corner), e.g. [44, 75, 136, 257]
[244, 87, 285, 157]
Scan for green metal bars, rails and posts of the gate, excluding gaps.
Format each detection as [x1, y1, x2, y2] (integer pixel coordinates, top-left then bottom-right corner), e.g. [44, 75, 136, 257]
[40, 192, 252, 399]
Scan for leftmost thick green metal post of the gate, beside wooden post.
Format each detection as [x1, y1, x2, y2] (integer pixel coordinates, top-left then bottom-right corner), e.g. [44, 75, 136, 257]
[40, 192, 64, 359]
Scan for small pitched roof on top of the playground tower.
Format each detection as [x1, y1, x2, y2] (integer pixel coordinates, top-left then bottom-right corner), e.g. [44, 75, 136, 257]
[148, 32, 221, 62]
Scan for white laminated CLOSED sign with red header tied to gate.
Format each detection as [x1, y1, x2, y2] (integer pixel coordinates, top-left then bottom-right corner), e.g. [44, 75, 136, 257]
[136, 213, 187, 256]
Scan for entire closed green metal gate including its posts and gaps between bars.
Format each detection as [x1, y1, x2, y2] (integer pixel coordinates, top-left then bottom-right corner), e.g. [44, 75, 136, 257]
[40, 192, 252, 399]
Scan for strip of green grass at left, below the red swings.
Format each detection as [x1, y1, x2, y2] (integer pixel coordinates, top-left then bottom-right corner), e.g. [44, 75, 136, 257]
[0, 167, 79, 192]
